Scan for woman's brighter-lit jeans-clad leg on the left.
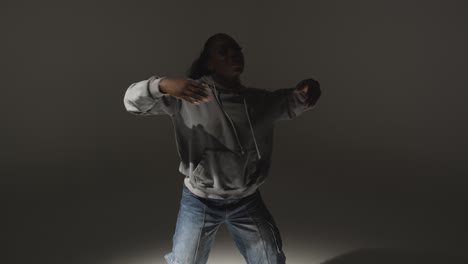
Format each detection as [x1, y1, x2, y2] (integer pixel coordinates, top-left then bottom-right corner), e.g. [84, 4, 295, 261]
[164, 185, 224, 264]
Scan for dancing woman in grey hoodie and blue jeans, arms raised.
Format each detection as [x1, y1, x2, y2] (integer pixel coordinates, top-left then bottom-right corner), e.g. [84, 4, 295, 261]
[124, 33, 321, 264]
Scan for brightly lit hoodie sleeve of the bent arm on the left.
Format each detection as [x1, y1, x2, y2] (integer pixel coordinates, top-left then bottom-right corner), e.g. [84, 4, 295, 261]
[123, 76, 181, 116]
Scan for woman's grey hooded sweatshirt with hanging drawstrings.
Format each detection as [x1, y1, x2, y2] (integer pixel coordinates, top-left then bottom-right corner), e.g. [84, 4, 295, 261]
[123, 75, 318, 199]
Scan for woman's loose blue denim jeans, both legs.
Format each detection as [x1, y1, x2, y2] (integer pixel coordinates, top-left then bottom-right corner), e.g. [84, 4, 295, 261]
[164, 184, 286, 264]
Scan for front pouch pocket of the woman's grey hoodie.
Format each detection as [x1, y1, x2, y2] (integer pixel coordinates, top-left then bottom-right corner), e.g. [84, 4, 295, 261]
[193, 149, 257, 190]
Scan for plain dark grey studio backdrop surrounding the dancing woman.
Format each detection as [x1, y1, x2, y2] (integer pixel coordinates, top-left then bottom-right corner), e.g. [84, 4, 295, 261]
[0, 0, 468, 264]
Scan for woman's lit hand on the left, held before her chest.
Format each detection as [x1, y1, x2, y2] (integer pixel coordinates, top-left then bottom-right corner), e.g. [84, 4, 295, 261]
[159, 77, 213, 105]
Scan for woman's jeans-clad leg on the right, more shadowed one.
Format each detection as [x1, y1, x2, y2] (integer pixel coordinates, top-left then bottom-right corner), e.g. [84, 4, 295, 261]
[226, 191, 286, 264]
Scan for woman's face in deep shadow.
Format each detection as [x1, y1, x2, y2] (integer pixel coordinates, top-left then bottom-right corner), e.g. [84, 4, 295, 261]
[208, 37, 244, 80]
